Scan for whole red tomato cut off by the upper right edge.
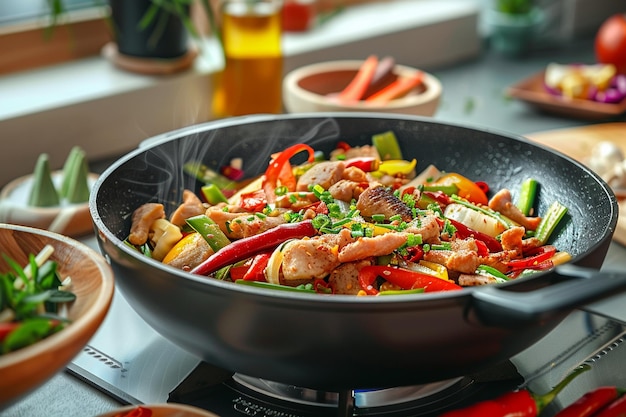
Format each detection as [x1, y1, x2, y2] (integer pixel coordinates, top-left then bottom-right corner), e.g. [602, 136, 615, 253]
[595, 13, 626, 74]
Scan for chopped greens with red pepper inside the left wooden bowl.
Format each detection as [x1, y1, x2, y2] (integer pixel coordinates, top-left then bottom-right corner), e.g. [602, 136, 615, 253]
[0, 245, 76, 355]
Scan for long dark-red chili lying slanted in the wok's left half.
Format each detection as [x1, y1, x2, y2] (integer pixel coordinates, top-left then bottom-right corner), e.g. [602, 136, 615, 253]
[191, 220, 317, 275]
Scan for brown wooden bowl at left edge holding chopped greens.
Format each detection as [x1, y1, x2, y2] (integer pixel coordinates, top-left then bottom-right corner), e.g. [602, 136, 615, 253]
[0, 223, 114, 410]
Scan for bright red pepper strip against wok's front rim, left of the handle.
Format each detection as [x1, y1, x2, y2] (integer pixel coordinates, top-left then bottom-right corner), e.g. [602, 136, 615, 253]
[359, 265, 462, 295]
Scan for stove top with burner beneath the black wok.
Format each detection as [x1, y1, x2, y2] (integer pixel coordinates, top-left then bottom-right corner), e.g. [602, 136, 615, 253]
[68, 239, 626, 417]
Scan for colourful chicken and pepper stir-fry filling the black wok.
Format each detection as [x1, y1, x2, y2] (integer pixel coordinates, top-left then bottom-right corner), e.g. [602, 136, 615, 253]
[123, 132, 570, 296]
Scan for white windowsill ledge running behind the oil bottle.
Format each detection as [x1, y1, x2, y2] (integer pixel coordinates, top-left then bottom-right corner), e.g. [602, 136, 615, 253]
[0, 0, 480, 186]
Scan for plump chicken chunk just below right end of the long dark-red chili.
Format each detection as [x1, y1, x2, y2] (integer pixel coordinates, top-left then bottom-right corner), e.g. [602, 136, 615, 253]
[281, 229, 353, 285]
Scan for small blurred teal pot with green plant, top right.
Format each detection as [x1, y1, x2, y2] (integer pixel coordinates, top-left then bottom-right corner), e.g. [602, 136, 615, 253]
[485, 0, 544, 56]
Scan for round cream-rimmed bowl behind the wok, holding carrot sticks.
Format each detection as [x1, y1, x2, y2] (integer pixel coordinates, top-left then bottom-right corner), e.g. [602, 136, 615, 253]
[283, 60, 442, 116]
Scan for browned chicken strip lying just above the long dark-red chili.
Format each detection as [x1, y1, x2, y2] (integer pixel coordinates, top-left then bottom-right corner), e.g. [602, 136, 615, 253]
[206, 207, 287, 239]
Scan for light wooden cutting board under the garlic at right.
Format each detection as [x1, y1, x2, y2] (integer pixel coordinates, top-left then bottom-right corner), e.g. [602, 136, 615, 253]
[525, 123, 626, 245]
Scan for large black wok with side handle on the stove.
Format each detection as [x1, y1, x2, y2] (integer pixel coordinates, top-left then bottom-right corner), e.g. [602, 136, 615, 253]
[90, 113, 626, 390]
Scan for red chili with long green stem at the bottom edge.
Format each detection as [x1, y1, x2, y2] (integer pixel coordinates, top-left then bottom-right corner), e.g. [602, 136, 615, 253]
[439, 365, 590, 417]
